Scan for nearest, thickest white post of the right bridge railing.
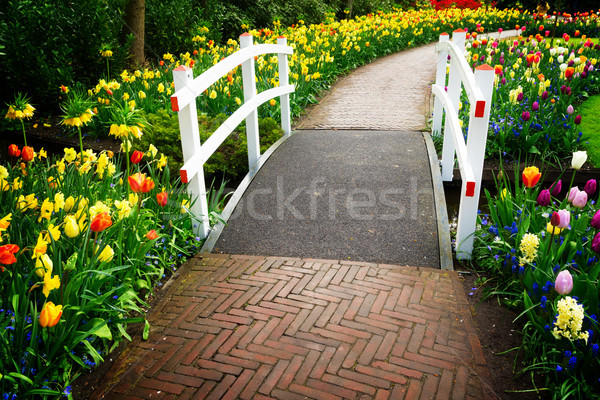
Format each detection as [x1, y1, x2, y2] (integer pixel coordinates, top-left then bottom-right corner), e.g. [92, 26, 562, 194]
[456, 64, 494, 259]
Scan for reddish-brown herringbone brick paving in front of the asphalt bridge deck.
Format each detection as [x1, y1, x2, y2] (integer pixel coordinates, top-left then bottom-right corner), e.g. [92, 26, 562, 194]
[95, 254, 495, 400]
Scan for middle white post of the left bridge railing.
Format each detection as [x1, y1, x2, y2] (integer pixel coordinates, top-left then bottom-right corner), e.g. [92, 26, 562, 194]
[240, 32, 260, 170]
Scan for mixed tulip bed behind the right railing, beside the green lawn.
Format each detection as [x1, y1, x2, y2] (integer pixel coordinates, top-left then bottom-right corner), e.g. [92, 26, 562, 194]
[460, 16, 600, 162]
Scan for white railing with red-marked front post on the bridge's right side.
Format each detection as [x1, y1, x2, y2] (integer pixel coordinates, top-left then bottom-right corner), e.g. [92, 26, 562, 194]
[432, 29, 494, 259]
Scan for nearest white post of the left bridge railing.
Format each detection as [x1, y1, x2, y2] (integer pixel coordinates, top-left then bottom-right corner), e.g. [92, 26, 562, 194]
[173, 65, 210, 238]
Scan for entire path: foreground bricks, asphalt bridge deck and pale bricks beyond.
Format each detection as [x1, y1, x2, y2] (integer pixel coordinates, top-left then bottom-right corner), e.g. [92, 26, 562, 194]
[92, 39, 510, 399]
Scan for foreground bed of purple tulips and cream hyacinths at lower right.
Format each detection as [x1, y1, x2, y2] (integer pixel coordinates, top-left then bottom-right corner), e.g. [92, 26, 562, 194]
[473, 152, 600, 399]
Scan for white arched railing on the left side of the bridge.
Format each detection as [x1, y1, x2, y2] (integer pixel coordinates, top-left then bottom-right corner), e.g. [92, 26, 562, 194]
[171, 33, 294, 238]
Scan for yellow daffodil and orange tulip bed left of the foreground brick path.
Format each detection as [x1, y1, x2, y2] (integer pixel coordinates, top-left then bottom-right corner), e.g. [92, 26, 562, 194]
[0, 145, 200, 399]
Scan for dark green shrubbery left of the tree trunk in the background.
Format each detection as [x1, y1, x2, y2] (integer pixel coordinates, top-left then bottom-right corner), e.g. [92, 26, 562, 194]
[0, 0, 127, 110]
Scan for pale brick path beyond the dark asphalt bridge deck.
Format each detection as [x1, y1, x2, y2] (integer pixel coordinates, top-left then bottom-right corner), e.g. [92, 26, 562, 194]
[295, 43, 436, 131]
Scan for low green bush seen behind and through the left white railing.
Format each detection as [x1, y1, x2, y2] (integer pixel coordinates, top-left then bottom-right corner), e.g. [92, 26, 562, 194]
[140, 110, 282, 179]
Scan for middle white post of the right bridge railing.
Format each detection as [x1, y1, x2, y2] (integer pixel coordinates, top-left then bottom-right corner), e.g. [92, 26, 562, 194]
[442, 29, 467, 181]
